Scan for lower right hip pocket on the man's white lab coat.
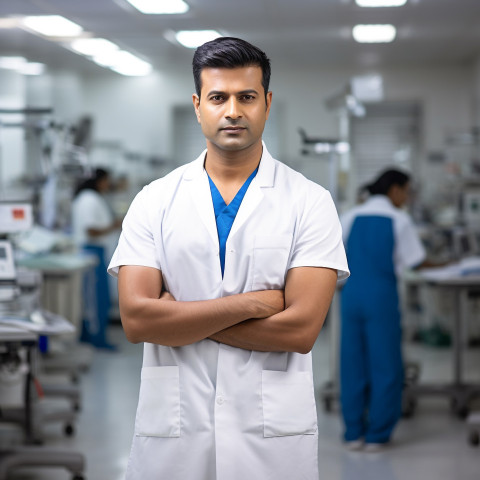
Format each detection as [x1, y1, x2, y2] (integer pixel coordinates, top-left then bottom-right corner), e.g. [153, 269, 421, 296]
[262, 370, 317, 437]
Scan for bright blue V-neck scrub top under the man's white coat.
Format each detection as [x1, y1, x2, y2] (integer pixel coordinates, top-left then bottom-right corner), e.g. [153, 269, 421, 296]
[207, 167, 258, 278]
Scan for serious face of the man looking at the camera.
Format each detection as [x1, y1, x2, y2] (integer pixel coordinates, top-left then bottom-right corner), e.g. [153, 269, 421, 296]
[193, 66, 272, 151]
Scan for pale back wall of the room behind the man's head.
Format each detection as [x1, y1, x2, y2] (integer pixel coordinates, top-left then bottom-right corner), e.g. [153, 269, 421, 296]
[0, 60, 472, 202]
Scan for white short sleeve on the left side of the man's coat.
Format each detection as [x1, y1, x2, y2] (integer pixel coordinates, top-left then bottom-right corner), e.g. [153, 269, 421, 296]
[108, 187, 161, 277]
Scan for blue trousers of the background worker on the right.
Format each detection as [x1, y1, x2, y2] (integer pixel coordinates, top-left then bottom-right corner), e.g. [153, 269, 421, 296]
[340, 278, 403, 443]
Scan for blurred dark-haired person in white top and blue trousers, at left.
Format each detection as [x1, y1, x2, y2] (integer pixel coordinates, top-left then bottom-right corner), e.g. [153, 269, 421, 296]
[72, 168, 122, 349]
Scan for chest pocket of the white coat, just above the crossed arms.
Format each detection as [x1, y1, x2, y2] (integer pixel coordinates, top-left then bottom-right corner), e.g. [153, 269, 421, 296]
[252, 234, 292, 290]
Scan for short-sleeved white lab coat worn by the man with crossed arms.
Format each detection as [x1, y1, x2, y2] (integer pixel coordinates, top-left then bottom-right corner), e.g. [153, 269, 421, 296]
[109, 145, 348, 480]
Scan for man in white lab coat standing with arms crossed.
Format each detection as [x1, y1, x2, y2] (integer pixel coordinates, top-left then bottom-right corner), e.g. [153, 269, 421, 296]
[109, 38, 348, 480]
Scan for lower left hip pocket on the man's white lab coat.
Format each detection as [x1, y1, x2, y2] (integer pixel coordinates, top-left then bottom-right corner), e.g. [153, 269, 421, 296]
[135, 366, 180, 437]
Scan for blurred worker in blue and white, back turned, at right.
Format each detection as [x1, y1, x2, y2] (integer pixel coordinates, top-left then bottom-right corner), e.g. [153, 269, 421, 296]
[340, 169, 425, 451]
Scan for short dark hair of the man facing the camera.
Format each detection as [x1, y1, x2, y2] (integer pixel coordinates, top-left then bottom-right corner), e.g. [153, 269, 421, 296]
[192, 37, 271, 98]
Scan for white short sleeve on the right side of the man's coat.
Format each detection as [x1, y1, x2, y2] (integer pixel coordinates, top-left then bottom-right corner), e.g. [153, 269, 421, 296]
[289, 189, 350, 280]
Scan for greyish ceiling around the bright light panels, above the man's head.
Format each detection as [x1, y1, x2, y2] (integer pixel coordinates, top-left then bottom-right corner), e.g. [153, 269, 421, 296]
[0, 0, 480, 72]
